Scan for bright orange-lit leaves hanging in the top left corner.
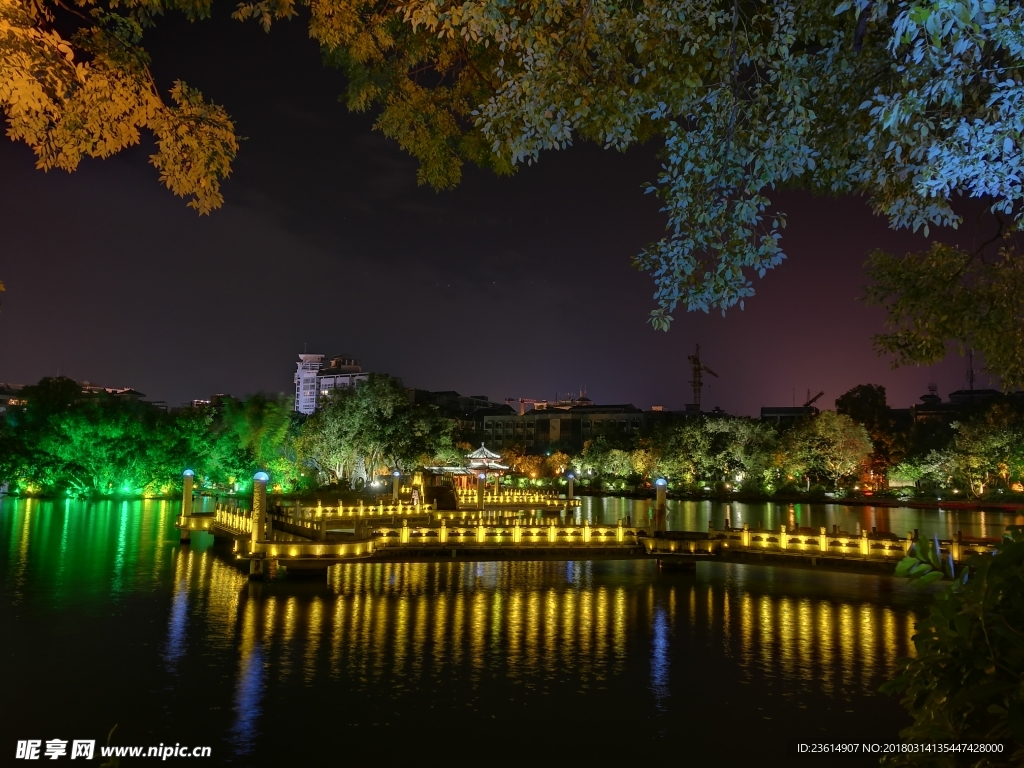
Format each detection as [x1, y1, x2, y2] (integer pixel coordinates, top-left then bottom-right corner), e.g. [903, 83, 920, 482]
[0, 0, 238, 213]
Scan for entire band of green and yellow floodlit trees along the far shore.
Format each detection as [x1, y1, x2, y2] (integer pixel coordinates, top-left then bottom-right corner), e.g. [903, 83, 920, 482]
[0, 376, 1024, 500]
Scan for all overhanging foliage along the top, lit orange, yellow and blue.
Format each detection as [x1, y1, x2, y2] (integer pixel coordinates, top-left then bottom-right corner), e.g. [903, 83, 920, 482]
[0, 0, 1024, 331]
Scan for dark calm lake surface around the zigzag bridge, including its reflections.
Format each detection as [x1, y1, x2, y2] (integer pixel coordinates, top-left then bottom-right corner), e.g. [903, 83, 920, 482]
[6, 499, 1016, 766]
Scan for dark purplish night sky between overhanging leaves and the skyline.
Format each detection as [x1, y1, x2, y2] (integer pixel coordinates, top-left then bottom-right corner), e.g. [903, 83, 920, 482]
[0, 6, 994, 415]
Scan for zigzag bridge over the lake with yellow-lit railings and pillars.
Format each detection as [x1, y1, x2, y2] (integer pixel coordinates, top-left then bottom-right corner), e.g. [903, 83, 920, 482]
[176, 473, 998, 579]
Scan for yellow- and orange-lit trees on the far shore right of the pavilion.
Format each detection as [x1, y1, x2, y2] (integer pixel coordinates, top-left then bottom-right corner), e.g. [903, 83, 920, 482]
[536, 385, 1024, 501]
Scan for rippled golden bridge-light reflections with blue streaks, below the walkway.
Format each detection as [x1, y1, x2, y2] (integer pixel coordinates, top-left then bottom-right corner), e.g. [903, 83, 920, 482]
[153, 551, 914, 712]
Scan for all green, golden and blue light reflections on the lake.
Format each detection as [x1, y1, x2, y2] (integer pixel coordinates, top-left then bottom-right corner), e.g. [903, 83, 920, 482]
[0, 500, 942, 765]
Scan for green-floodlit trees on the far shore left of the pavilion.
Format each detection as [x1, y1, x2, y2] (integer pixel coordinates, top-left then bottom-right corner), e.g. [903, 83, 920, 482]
[0, 376, 459, 496]
